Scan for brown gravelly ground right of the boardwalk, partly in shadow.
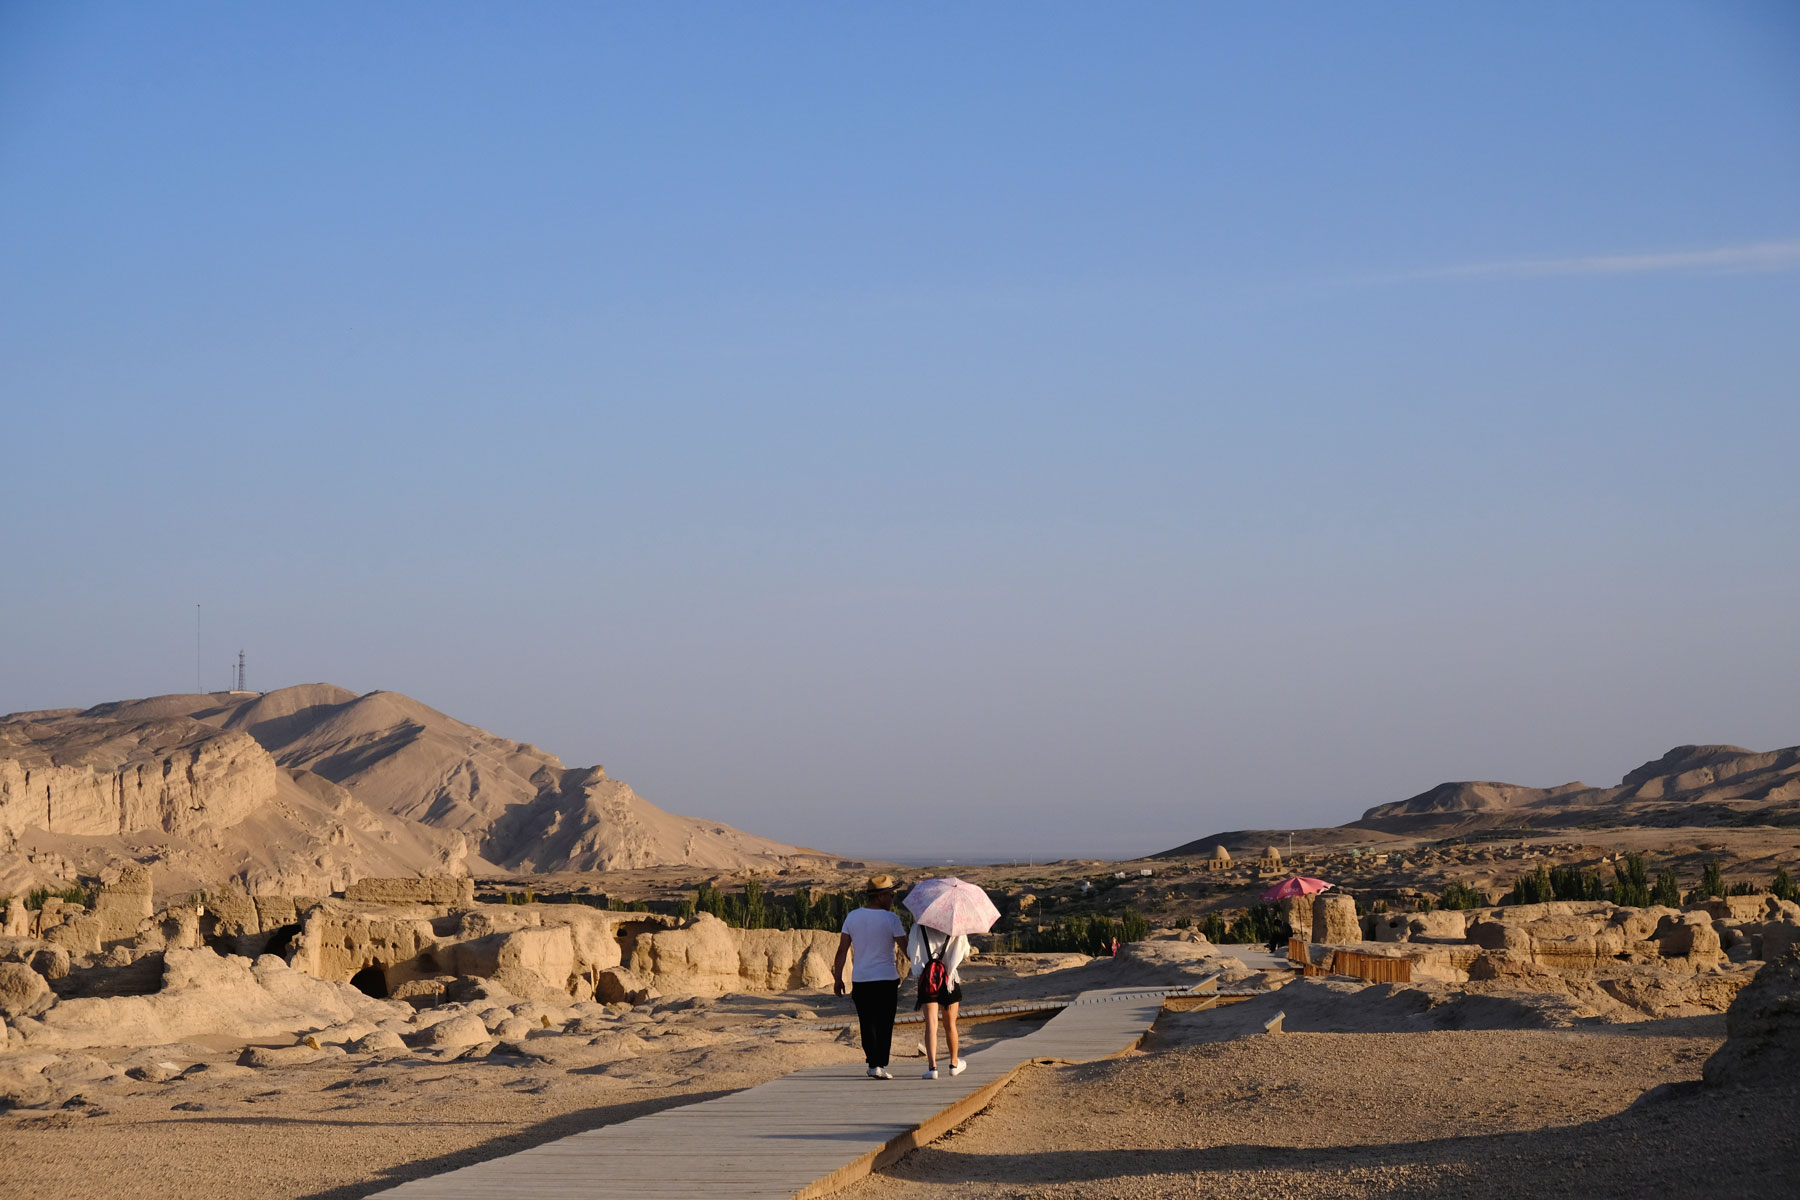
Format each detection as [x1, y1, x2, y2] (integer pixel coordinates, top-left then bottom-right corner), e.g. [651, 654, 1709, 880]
[842, 1013, 1800, 1200]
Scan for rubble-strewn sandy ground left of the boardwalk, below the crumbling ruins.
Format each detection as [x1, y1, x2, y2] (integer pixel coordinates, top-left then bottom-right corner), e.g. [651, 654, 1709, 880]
[0, 995, 1037, 1200]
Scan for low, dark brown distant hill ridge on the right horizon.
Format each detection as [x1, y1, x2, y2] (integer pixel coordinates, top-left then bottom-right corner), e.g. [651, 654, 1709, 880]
[1154, 745, 1800, 858]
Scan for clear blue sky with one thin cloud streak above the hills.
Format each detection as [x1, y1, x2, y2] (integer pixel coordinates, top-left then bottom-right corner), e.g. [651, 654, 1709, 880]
[0, 2, 1800, 856]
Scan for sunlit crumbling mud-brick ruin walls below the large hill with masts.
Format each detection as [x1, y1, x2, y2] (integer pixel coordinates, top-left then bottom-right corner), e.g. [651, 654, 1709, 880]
[0, 867, 837, 1045]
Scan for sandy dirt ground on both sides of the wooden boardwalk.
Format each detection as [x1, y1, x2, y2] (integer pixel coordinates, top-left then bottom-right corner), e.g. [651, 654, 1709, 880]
[0, 943, 1800, 1200]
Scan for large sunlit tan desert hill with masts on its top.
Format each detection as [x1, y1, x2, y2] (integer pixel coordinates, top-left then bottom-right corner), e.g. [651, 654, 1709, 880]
[0, 684, 824, 894]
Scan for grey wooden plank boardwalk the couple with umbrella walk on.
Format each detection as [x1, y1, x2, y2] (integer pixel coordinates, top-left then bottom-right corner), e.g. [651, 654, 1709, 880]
[378, 988, 1192, 1200]
